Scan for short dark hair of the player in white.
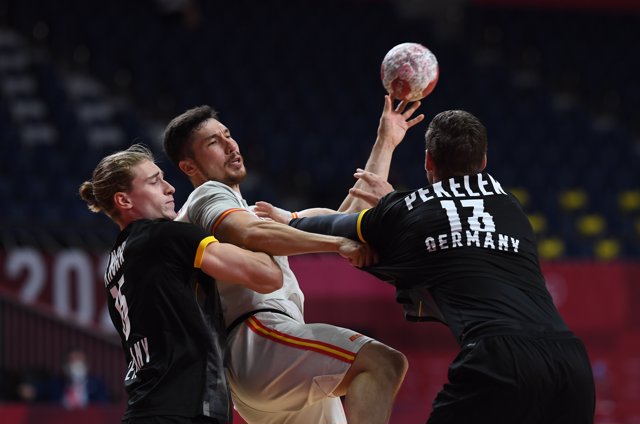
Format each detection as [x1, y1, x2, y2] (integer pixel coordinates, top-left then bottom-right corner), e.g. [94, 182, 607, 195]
[162, 105, 218, 167]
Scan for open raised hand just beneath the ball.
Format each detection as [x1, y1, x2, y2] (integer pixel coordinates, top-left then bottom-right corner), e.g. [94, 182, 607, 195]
[378, 95, 424, 148]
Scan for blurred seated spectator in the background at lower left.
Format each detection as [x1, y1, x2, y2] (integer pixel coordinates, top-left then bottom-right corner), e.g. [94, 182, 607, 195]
[46, 349, 110, 409]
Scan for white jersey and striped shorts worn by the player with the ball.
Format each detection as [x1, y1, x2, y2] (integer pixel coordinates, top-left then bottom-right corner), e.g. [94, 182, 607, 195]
[176, 182, 372, 424]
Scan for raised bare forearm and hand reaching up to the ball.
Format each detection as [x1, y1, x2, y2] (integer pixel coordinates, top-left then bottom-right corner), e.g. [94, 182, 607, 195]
[338, 95, 424, 212]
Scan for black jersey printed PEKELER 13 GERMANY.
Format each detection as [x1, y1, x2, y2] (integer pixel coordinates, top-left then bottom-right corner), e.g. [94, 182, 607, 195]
[358, 173, 567, 341]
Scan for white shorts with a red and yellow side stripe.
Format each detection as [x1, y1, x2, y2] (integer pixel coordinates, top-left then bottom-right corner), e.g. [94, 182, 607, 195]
[228, 311, 372, 424]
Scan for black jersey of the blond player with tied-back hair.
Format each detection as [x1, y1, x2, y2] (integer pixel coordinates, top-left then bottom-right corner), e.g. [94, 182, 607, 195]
[105, 220, 231, 422]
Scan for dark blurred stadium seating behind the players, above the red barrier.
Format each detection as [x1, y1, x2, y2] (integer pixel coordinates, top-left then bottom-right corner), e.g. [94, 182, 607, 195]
[0, 0, 639, 257]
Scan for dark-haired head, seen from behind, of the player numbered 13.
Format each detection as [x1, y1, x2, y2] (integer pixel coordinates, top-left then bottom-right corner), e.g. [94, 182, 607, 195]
[425, 110, 488, 179]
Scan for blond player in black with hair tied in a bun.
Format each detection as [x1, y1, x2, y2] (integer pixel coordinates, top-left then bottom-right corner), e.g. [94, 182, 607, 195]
[80, 145, 282, 424]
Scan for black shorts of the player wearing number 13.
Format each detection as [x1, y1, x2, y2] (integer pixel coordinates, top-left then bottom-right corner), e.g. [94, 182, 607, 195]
[427, 333, 595, 424]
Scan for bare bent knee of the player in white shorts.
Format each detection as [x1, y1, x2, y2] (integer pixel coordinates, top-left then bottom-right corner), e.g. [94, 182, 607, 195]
[333, 341, 408, 424]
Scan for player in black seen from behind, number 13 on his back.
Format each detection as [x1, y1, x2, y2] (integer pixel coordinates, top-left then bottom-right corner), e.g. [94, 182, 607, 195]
[258, 110, 595, 424]
